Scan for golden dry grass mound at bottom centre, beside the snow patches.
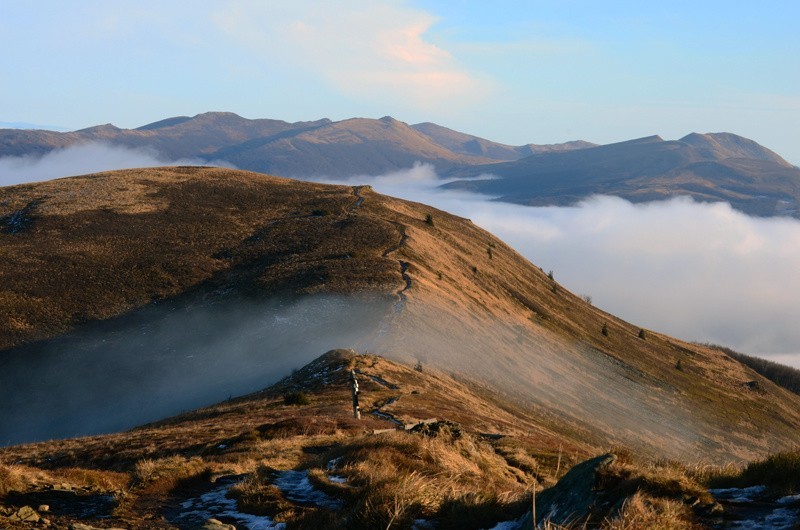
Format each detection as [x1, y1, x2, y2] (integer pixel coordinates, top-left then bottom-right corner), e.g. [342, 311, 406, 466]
[235, 432, 532, 528]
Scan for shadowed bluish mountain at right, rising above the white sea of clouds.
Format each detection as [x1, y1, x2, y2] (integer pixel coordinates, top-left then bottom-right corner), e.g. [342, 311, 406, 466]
[447, 133, 800, 217]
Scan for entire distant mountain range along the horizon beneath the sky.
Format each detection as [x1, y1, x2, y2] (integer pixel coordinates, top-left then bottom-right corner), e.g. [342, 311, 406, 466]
[0, 112, 800, 217]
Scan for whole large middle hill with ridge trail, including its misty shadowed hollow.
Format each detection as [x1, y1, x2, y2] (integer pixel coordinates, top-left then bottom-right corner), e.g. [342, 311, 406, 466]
[0, 168, 800, 460]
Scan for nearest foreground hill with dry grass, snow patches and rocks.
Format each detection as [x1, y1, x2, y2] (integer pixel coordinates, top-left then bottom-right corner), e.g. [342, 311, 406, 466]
[0, 350, 800, 530]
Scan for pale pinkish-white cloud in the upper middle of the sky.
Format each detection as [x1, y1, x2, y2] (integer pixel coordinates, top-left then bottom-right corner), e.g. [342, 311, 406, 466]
[209, 0, 490, 110]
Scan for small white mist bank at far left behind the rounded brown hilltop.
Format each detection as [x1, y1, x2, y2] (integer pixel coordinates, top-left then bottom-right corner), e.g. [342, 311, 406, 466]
[0, 142, 234, 186]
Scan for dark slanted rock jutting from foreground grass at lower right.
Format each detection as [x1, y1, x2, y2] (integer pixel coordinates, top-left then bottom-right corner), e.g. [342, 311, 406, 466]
[519, 454, 617, 528]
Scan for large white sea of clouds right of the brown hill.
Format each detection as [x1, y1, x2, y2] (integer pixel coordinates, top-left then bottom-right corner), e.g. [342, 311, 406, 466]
[320, 164, 800, 368]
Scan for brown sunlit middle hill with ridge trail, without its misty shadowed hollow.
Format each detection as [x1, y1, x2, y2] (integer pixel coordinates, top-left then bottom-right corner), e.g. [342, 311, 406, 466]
[0, 168, 800, 459]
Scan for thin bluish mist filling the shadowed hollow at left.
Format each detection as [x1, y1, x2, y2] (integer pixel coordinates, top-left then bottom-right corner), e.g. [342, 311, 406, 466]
[0, 290, 391, 446]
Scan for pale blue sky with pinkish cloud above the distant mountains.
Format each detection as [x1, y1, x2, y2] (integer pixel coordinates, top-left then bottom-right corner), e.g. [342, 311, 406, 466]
[0, 0, 800, 164]
